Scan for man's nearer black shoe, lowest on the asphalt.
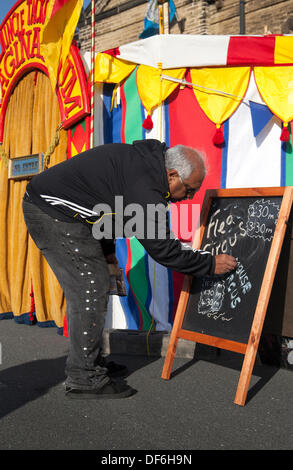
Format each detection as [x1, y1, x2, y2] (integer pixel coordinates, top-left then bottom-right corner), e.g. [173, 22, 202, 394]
[65, 380, 136, 400]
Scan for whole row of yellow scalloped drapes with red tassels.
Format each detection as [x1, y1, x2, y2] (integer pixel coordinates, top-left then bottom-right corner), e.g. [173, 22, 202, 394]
[95, 51, 293, 145]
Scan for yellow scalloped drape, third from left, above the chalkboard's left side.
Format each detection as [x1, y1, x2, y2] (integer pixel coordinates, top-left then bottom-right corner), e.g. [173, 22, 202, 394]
[190, 67, 250, 126]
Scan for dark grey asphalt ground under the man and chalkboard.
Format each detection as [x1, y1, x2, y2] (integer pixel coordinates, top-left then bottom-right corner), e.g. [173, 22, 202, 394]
[0, 320, 293, 458]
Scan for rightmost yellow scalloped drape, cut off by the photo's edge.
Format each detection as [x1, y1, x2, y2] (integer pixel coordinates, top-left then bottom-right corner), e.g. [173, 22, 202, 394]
[254, 66, 293, 124]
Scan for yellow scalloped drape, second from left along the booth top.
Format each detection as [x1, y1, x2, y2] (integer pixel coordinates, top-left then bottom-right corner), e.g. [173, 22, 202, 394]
[136, 65, 186, 114]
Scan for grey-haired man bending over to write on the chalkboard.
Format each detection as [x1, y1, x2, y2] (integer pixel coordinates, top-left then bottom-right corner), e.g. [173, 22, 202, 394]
[23, 139, 236, 398]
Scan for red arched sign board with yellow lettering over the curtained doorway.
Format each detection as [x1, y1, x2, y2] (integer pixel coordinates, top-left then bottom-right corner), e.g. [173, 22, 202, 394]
[0, 0, 90, 142]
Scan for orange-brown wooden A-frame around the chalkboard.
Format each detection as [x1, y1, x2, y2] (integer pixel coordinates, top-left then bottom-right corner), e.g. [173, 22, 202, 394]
[161, 186, 293, 406]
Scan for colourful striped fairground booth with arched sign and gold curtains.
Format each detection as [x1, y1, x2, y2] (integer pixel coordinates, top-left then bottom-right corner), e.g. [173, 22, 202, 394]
[0, 0, 293, 368]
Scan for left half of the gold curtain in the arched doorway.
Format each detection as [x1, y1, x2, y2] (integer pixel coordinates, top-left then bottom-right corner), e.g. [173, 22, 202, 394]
[0, 75, 34, 315]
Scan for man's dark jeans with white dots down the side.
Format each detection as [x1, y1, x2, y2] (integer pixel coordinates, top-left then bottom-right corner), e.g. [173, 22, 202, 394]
[23, 196, 110, 389]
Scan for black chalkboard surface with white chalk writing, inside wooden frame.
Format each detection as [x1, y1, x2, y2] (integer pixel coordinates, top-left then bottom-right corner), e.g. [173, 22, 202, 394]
[182, 197, 282, 343]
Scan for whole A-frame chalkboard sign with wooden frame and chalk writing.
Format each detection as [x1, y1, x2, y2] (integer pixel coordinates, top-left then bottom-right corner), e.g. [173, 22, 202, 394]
[162, 187, 293, 405]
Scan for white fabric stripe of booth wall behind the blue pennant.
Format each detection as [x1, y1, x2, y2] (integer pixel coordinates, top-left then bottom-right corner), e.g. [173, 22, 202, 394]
[221, 76, 284, 188]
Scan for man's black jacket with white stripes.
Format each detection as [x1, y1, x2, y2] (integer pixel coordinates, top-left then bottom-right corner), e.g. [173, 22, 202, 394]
[27, 139, 214, 276]
